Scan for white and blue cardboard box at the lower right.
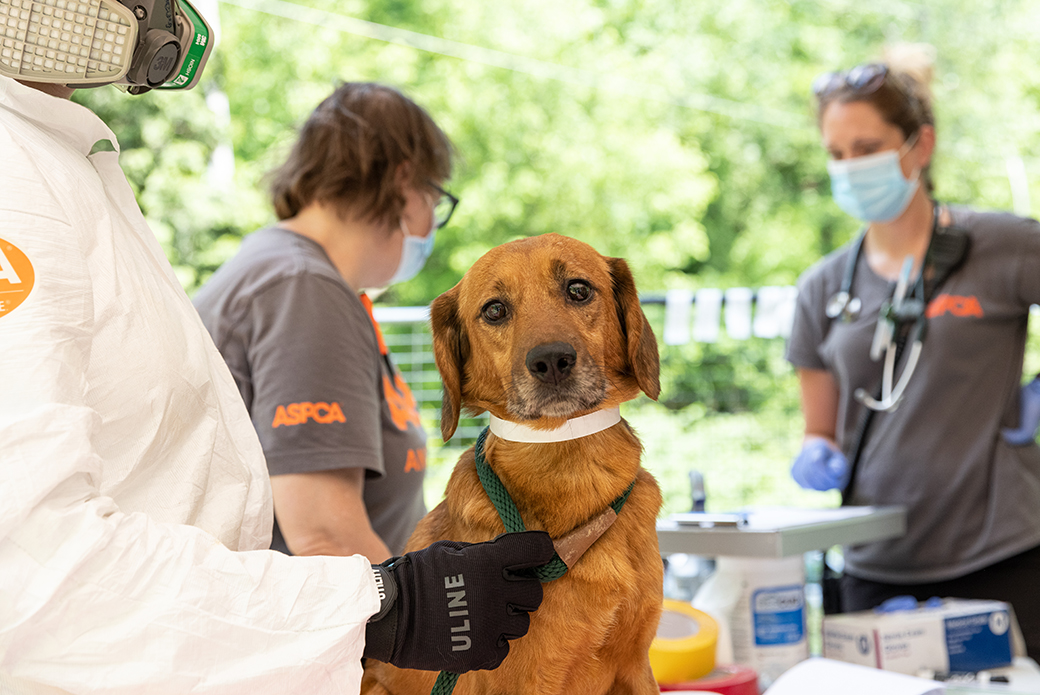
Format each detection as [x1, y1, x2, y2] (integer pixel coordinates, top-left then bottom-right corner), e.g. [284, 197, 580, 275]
[823, 598, 1014, 674]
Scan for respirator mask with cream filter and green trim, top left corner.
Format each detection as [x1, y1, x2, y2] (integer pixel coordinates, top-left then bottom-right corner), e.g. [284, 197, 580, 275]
[0, 0, 213, 94]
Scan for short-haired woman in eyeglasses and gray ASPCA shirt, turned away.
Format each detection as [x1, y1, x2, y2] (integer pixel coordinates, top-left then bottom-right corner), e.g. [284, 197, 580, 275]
[194, 83, 458, 563]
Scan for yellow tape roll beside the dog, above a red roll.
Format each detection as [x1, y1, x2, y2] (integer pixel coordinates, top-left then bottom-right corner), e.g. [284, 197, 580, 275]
[650, 598, 719, 684]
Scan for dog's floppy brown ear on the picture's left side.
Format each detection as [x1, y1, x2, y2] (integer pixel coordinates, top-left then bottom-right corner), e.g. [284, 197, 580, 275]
[430, 285, 469, 441]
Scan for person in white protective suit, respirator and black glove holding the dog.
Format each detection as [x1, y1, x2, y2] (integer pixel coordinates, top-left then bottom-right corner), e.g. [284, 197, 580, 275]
[0, 0, 552, 695]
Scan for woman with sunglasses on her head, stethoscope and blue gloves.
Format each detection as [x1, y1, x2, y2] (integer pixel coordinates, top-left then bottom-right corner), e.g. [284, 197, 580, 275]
[787, 50, 1040, 657]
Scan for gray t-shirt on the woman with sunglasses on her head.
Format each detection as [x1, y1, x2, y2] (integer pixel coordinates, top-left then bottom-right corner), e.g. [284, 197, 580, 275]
[787, 208, 1040, 584]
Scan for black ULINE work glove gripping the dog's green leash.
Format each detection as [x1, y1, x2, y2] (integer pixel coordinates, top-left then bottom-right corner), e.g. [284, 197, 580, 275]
[364, 531, 553, 673]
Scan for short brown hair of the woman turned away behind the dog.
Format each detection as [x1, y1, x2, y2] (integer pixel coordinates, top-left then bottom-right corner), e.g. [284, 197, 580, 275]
[270, 82, 452, 221]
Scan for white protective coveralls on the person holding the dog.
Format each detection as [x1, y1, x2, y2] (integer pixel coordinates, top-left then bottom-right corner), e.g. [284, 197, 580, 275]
[0, 77, 379, 695]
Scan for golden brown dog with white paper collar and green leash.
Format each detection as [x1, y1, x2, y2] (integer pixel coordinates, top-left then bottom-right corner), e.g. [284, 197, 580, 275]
[362, 234, 661, 695]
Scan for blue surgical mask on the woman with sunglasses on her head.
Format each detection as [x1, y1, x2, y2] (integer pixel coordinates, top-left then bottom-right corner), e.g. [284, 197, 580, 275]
[827, 138, 920, 222]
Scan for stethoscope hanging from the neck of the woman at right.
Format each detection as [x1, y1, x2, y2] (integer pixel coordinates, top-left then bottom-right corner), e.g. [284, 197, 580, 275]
[826, 203, 939, 412]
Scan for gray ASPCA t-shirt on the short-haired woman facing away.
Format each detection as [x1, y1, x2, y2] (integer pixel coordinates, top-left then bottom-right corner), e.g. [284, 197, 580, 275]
[194, 227, 426, 555]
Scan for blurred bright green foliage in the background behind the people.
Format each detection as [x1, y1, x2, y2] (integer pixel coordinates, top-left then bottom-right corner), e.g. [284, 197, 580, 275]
[75, 0, 1040, 510]
